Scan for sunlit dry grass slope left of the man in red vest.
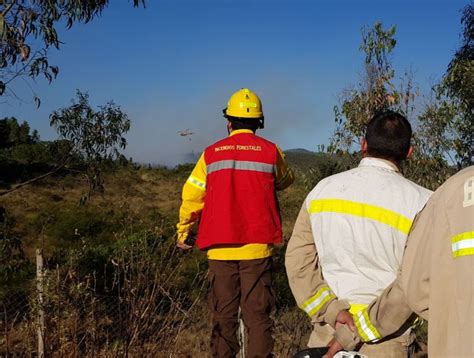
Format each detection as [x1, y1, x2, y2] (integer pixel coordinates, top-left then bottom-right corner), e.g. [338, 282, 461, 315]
[0, 169, 184, 258]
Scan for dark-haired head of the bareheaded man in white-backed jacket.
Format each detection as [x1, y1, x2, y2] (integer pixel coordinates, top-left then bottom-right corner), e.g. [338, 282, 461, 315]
[365, 111, 412, 163]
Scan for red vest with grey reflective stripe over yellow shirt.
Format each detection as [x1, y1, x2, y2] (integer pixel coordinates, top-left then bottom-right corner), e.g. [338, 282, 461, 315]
[196, 133, 282, 249]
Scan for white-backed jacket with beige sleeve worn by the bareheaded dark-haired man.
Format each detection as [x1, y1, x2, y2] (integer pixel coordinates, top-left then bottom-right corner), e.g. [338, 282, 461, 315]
[285, 157, 431, 330]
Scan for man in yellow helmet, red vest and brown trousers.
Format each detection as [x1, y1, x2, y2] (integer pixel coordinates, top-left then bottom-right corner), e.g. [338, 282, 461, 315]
[177, 88, 294, 357]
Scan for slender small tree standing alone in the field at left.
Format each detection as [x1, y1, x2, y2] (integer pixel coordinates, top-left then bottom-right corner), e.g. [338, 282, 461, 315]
[50, 90, 130, 201]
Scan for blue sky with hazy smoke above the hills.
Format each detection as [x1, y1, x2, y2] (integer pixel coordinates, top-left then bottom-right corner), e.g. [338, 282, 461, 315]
[0, 0, 468, 165]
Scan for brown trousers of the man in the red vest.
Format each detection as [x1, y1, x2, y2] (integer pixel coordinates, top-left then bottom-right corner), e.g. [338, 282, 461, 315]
[209, 257, 275, 358]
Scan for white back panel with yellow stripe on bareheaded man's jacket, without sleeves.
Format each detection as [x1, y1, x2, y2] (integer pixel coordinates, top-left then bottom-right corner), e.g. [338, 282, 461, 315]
[305, 158, 431, 304]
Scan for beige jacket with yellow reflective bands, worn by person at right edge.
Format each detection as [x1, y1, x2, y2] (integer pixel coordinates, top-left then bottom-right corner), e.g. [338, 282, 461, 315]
[336, 166, 474, 357]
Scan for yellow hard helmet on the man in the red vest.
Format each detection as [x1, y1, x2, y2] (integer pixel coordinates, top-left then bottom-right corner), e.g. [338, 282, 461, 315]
[224, 88, 263, 119]
